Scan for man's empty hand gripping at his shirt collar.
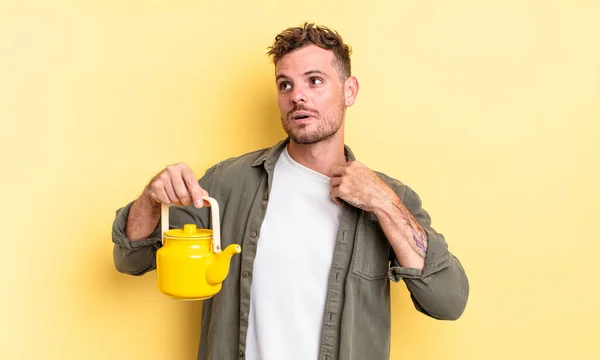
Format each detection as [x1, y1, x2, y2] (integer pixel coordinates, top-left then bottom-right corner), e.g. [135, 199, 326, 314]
[329, 161, 396, 211]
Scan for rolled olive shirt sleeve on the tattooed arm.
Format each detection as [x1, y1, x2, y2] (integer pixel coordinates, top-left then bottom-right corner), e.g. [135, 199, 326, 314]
[389, 185, 469, 320]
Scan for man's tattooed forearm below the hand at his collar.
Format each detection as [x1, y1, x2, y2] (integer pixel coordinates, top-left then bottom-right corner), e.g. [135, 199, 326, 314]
[374, 194, 428, 270]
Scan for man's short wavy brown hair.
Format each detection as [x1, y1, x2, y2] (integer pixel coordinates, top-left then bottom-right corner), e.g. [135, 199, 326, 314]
[267, 23, 352, 80]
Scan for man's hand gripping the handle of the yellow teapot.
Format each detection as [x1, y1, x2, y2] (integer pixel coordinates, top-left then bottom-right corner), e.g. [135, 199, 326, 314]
[144, 163, 210, 208]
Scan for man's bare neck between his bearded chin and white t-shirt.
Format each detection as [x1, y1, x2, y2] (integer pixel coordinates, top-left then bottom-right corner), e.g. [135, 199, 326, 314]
[288, 135, 346, 177]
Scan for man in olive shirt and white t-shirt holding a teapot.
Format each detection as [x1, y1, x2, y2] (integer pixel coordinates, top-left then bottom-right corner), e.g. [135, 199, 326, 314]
[113, 24, 469, 360]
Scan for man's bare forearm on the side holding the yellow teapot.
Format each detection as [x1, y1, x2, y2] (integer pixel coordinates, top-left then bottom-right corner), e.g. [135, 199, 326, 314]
[125, 191, 160, 241]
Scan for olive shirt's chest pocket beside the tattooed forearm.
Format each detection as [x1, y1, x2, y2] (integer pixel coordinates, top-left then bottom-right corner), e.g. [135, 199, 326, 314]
[352, 214, 390, 281]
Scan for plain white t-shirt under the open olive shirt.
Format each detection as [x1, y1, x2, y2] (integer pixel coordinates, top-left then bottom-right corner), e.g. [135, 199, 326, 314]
[246, 147, 341, 360]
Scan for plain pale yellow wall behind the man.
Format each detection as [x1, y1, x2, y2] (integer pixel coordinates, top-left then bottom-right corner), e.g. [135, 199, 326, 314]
[0, 0, 600, 360]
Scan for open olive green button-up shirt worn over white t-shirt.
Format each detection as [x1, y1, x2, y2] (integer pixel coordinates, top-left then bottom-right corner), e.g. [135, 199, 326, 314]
[112, 140, 469, 360]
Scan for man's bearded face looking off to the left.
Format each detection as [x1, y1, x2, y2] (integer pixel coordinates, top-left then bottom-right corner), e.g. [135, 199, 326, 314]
[275, 45, 346, 144]
